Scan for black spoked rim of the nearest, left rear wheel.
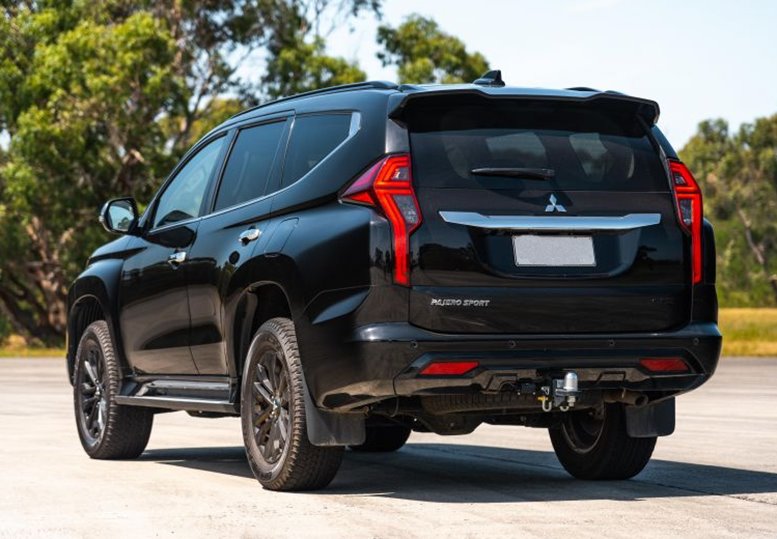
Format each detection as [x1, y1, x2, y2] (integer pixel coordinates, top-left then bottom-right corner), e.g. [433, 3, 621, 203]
[252, 351, 291, 464]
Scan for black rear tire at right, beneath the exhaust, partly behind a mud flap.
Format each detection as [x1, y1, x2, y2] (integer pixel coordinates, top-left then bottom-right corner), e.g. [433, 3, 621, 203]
[549, 404, 656, 480]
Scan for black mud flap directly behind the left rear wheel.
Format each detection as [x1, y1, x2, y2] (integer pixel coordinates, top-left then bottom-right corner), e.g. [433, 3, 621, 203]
[302, 368, 367, 446]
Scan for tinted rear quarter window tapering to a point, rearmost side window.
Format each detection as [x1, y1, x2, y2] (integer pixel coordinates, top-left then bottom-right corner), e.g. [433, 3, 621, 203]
[283, 113, 351, 186]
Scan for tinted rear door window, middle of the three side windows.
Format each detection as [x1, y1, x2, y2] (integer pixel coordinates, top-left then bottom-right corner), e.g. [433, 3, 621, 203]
[215, 121, 286, 211]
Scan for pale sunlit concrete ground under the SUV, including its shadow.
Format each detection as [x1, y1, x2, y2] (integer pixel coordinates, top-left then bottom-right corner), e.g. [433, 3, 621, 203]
[0, 358, 777, 538]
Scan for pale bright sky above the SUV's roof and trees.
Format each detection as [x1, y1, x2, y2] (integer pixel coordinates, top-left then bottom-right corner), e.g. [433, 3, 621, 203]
[327, 0, 777, 149]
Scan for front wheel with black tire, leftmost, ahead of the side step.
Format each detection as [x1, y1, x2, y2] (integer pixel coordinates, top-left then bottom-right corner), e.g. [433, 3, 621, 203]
[73, 320, 154, 459]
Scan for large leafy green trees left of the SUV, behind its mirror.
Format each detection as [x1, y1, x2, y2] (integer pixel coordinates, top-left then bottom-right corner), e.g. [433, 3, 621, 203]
[0, 0, 380, 344]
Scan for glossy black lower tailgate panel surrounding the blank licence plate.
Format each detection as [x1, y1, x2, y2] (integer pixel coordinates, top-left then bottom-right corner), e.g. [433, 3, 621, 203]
[410, 189, 691, 333]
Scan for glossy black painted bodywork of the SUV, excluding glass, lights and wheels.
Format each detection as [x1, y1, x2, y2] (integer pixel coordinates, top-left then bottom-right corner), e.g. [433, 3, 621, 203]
[68, 81, 720, 426]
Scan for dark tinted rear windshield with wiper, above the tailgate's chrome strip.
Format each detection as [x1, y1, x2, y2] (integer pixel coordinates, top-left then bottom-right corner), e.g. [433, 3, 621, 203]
[406, 98, 669, 191]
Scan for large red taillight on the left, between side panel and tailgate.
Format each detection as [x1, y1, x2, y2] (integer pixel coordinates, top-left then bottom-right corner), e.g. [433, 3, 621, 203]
[341, 154, 421, 286]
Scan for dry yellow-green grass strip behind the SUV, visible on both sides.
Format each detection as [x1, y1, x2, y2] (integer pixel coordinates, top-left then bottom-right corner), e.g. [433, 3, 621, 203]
[0, 309, 777, 358]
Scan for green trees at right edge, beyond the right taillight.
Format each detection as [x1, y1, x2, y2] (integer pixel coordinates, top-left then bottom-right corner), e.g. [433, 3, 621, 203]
[681, 115, 777, 305]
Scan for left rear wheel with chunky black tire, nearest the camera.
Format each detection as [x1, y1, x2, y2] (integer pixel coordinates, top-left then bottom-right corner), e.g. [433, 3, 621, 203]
[240, 318, 345, 491]
